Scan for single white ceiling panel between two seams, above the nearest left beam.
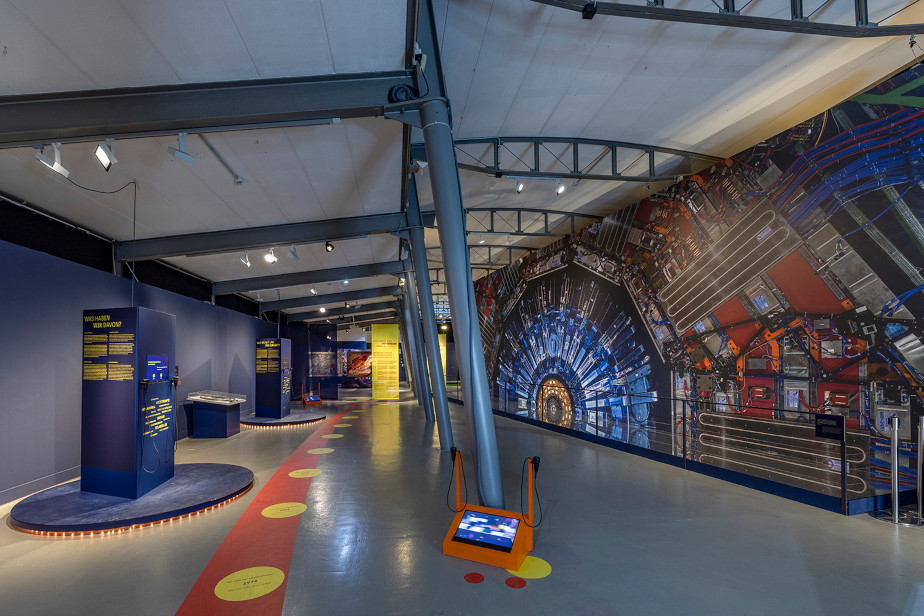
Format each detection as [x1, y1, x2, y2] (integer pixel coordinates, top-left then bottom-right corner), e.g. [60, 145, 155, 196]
[225, 0, 334, 78]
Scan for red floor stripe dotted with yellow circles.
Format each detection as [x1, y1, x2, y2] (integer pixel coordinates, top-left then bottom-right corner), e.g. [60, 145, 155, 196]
[177, 403, 359, 616]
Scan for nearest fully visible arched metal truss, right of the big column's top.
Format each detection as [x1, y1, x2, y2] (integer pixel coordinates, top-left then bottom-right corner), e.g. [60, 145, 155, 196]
[411, 136, 724, 182]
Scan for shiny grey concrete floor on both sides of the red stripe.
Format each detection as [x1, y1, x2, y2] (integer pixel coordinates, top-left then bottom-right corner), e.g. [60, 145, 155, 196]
[0, 392, 924, 616]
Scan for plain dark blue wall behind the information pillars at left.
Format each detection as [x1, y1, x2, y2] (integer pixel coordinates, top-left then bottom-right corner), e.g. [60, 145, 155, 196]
[0, 242, 277, 503]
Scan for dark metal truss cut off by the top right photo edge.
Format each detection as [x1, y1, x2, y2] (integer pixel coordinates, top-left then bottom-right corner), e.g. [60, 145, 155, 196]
[533, 0, 924, 38]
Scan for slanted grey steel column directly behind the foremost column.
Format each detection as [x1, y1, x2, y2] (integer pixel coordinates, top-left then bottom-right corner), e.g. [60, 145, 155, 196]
[410, 227, 454, 451]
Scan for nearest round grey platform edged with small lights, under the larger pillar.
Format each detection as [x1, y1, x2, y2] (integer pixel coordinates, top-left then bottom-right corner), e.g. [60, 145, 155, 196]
[10, 464, 253, 534]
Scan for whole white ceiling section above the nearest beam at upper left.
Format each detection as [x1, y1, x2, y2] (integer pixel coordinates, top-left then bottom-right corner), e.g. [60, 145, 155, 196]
[0, 0, 407, 94]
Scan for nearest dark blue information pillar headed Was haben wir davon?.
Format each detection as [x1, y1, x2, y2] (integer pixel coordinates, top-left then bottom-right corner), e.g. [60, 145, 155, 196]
[80, 308, 176, 498]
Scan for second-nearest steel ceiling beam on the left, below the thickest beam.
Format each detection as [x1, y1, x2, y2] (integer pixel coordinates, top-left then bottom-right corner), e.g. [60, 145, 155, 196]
[115, 212, 434, 261]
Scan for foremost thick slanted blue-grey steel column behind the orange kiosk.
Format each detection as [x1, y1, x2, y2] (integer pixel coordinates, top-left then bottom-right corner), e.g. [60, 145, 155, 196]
[420, 100, 506, 509]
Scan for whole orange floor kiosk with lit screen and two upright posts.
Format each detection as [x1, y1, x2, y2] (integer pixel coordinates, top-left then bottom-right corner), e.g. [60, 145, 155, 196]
[443, 447, 539, 571]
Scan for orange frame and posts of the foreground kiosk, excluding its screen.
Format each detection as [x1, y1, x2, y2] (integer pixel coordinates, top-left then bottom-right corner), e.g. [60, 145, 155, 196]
[443, 447, 539, 571]
